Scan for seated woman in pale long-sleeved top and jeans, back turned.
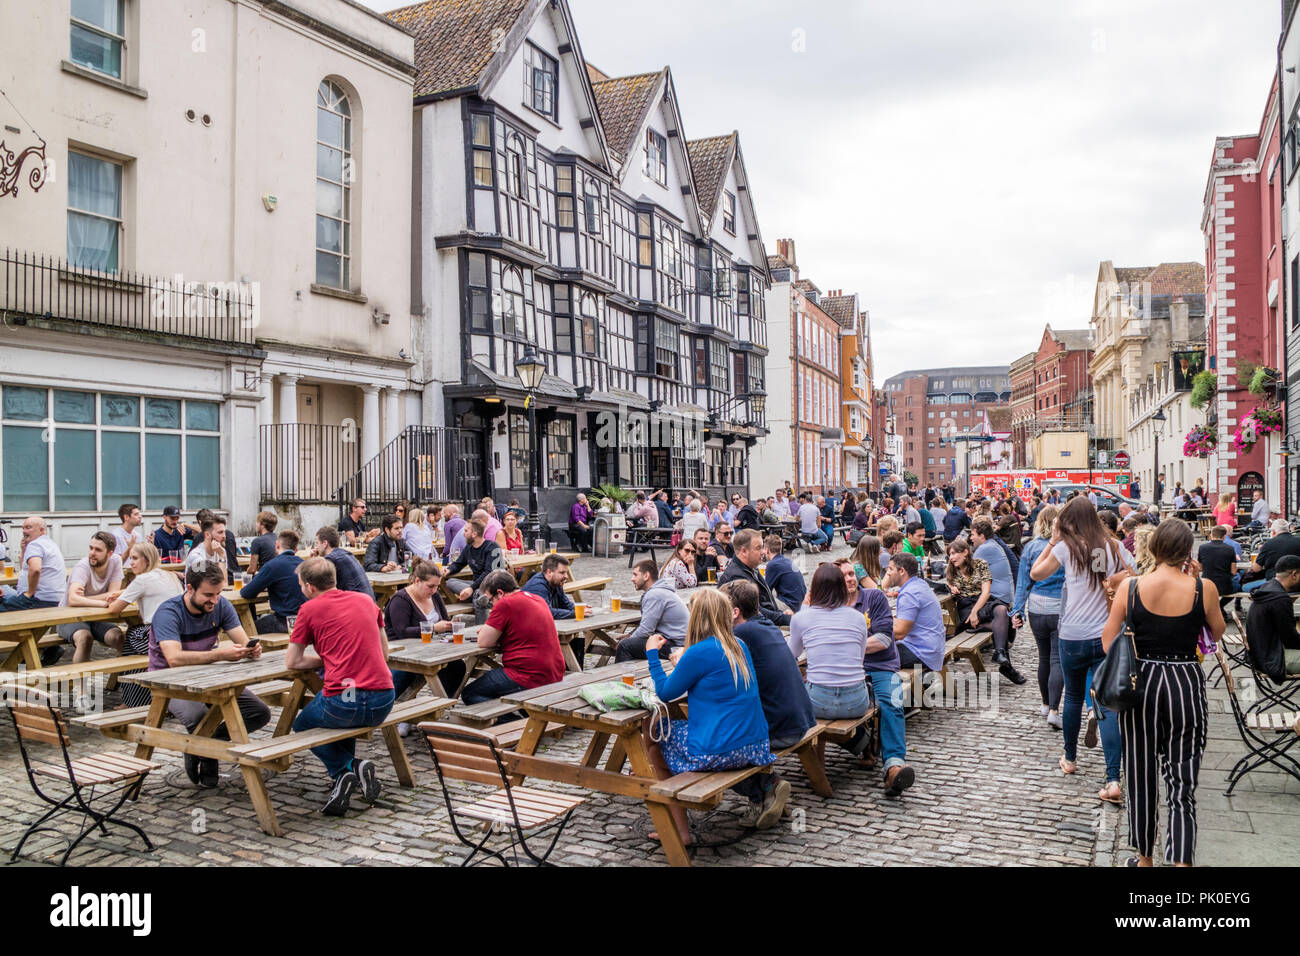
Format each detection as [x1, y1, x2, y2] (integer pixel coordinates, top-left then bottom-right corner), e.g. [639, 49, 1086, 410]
[785, 564, 881, 757]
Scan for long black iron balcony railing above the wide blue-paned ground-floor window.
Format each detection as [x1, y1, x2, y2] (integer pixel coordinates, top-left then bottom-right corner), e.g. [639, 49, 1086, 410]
[0, 248, 259, 345]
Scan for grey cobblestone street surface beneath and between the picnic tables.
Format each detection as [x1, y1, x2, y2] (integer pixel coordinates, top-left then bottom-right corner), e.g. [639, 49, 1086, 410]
[0, 541, 1300, 866]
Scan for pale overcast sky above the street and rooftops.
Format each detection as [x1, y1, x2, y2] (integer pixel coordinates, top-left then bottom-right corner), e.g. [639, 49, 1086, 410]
[368, 0, 1282, 385]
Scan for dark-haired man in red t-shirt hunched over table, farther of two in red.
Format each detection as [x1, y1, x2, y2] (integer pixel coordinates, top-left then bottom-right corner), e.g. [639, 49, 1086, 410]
[460, 571, 564, 704]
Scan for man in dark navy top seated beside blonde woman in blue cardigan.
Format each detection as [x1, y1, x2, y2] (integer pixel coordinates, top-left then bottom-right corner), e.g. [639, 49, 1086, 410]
[720, 579, 816, 830]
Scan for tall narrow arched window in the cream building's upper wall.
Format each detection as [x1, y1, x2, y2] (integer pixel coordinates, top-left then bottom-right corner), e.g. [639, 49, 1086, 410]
[316, 79, 352, 289]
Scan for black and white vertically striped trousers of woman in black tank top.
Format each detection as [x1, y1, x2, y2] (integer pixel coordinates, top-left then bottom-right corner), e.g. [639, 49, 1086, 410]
[1119, 661, 1209, 864]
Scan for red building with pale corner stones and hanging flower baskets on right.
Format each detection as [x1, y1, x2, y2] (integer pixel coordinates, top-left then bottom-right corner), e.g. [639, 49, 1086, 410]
[1201, 79, 1284, 511]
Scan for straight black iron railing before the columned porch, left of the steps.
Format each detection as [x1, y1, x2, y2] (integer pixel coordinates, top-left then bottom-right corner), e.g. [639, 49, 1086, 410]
[261, 424, 361, 505]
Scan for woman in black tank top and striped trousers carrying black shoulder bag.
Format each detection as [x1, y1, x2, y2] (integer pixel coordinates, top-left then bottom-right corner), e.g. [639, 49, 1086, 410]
[1101, 522, 1225, 866]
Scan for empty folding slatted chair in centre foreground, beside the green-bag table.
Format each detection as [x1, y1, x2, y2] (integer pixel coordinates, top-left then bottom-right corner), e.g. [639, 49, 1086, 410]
[420, 723, 584, 866]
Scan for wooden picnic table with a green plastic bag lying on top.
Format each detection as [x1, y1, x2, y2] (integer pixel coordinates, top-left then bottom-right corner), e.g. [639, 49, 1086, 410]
[491, 661, 717, 866]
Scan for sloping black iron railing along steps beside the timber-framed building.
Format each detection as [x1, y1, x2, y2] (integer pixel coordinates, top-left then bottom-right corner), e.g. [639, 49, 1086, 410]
[334, 425, 482, 516]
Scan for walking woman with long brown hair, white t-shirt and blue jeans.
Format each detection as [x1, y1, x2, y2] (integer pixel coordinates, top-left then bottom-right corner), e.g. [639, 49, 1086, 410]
[1030, 494, 1132, 804]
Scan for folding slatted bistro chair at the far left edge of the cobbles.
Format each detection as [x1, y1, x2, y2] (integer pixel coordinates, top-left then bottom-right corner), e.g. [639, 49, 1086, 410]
[0, 684, 159, 866]
